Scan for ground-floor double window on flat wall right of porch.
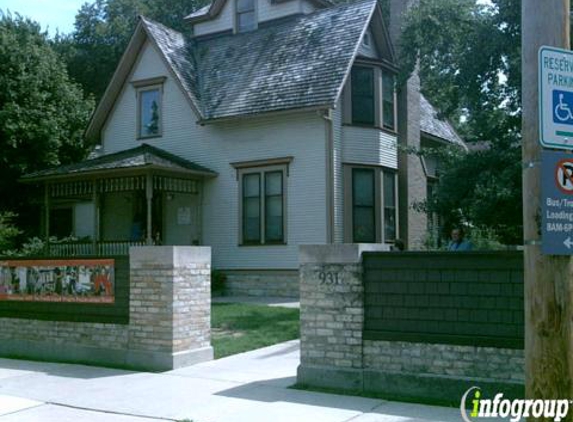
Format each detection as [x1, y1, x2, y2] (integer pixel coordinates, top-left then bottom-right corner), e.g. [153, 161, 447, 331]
[234, 158, 290, 245]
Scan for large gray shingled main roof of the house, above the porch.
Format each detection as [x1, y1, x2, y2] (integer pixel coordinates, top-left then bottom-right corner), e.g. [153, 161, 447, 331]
[143, 0, 376, 120]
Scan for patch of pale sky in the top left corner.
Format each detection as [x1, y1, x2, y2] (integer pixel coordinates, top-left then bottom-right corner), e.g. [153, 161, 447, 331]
[0, 0, 89, 35]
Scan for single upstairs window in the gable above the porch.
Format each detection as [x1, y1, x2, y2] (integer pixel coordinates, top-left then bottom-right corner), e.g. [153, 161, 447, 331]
[132, 77, 166, 139]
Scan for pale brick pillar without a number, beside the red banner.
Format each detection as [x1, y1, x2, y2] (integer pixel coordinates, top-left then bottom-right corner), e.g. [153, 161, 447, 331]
[127, 246, 213, 370]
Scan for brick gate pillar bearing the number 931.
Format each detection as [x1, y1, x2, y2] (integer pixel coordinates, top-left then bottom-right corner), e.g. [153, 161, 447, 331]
[298, 244, 388, 390]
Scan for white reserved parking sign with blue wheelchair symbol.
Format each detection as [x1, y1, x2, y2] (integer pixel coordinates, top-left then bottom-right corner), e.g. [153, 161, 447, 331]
[539, 47, 573, 149]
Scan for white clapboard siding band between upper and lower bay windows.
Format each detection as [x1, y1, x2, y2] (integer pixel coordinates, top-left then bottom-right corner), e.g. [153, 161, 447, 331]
[342, 126, 398, 169]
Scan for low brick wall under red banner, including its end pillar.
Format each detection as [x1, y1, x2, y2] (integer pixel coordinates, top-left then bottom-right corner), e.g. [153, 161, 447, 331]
[0, 246, 213, 370]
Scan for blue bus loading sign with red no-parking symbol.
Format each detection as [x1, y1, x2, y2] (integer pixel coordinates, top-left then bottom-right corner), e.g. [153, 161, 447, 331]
[541, 151, 573, 255]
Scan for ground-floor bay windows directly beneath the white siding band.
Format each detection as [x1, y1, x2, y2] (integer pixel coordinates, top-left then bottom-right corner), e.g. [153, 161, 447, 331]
[344, 166, 398, 243]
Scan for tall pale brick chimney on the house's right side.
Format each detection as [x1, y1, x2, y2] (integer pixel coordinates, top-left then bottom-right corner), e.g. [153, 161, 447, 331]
[389, 0, 427, 250]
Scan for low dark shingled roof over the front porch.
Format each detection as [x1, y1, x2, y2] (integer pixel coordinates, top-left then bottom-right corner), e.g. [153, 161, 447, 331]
[21, 144, 217, 182]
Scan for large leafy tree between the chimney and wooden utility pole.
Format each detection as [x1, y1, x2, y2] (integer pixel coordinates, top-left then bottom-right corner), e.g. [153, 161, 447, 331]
[400, 0, 522, 243]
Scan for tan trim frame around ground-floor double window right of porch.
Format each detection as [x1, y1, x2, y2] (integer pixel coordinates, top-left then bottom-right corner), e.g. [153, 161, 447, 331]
[232, 162, 292, 247]
